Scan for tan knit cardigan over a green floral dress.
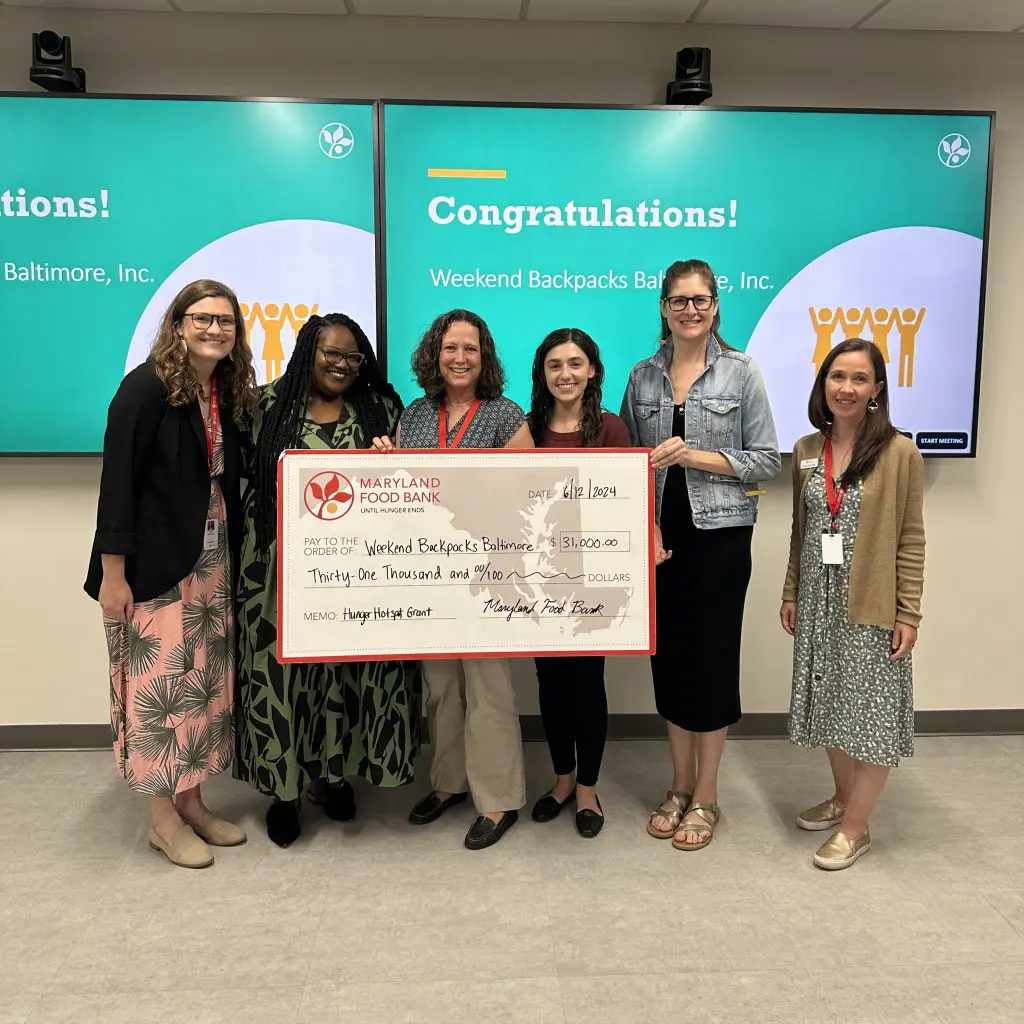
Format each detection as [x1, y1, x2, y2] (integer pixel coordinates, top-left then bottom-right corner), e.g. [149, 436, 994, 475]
[782, 433, 925, 630]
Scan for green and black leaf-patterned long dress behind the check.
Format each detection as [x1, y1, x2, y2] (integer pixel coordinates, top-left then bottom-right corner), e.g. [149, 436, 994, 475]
[234, 384, 421, 800]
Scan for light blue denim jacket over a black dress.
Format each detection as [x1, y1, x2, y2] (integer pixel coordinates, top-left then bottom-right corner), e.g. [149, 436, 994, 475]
[622, 337, 782, 529]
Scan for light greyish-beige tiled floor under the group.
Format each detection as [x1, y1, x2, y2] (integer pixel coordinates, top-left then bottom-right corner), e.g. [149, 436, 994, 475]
[0, 736, 1024, 1024]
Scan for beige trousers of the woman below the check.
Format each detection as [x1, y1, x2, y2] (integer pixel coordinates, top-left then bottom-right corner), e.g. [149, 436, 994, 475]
[422, 657, 526, 814]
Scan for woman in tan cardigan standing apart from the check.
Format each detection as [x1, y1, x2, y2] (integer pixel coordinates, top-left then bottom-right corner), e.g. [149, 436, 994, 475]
[780, 339, 925, 870]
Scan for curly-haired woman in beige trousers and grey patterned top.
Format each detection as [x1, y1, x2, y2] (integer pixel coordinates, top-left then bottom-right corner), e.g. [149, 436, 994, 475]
[375, 309, 534, 850]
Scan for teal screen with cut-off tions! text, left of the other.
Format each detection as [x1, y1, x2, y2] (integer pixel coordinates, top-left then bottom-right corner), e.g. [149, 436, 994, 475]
[0, 95, 377, 453]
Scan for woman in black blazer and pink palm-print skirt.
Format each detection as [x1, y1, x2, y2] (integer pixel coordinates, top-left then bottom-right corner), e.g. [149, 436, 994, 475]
[85, 281, 256, 867]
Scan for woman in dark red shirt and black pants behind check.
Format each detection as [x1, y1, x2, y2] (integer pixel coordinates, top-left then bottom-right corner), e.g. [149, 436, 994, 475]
[527, 328, 631, 839]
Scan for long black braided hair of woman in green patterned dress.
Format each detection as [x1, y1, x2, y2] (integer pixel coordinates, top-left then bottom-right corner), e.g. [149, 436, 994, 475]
[252, 313, 402, 551]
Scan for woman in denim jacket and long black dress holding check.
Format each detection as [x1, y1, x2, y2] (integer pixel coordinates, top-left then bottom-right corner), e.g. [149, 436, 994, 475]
[622, 260, 781, 850]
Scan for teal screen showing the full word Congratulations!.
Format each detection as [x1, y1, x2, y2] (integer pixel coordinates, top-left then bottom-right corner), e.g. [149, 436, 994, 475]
[383, 103, 992, 455]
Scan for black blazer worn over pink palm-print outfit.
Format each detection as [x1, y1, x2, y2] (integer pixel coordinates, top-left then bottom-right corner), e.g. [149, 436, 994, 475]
[85, 360, 242, 602]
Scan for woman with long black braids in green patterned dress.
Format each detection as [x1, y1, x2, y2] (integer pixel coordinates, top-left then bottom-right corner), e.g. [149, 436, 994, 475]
[234, 313, 421, 846]
